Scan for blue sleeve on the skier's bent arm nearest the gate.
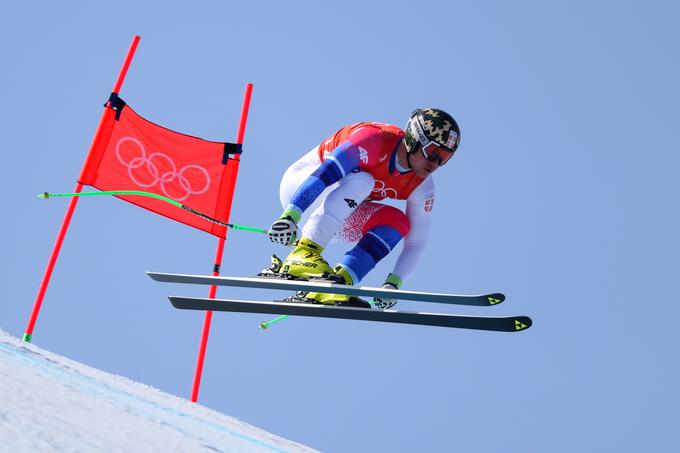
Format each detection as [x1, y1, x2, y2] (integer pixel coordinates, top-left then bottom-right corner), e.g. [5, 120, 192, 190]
[286, 140, 360, 214]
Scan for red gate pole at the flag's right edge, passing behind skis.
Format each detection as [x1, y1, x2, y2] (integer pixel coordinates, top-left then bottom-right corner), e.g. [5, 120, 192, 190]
[191, 83, 253, 403]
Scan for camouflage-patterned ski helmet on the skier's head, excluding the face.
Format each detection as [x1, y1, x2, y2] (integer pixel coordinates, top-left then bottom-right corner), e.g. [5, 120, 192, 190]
[404, 108, 460, 154]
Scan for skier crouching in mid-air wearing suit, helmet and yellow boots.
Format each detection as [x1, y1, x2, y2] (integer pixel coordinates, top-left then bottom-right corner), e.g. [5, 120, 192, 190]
[268, 108, 460, 309]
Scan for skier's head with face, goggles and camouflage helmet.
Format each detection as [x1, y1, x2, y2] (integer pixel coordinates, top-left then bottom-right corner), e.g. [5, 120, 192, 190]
[404, 108, 460, 166]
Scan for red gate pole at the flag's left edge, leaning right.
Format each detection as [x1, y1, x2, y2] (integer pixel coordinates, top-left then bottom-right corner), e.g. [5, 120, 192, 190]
[23, 35, 140, 342]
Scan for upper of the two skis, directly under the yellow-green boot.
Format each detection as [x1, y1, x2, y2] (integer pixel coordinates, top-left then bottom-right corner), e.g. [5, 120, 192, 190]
[147, 272, 505, 306]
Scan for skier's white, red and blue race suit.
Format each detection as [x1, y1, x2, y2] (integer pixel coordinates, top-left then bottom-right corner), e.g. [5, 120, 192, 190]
[280, 122, 435, 283]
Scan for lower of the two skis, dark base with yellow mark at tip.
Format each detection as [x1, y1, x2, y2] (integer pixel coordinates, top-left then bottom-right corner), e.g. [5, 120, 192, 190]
[169, 296, 531, 332]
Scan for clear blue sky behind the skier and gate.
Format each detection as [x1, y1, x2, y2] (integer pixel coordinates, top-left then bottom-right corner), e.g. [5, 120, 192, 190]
[0, 1, 680, 452]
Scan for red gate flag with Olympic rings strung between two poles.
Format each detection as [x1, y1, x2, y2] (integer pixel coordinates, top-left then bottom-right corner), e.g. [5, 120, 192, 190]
[78, 94, 241, 238]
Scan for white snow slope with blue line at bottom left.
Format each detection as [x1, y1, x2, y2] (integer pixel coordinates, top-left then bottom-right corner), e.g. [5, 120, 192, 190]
[0, 330, 316, 453]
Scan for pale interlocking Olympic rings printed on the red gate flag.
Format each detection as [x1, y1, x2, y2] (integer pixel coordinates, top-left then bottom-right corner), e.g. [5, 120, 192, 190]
[116, 137, 210, 201]
